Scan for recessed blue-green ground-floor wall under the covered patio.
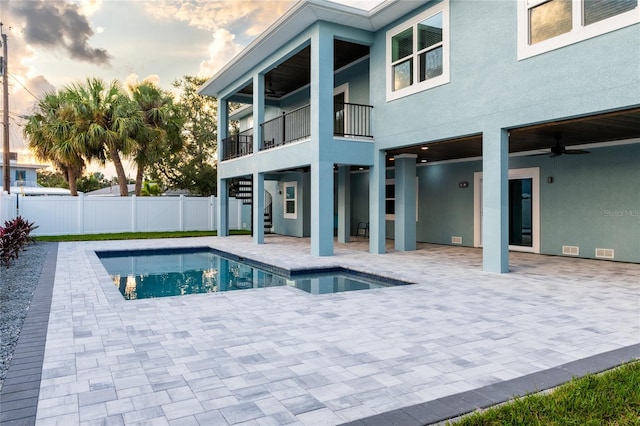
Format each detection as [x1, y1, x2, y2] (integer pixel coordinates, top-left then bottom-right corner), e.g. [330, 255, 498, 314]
[376, 144, 640, 262]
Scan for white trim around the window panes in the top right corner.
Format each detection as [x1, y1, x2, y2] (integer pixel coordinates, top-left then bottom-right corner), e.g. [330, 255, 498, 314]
[517, 0, 640, 60]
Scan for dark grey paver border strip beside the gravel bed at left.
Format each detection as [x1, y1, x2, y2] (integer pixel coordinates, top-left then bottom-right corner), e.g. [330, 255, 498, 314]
[0, 243, 58, 426]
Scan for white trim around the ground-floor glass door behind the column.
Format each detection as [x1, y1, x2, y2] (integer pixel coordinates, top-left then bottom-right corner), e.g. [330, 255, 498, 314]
[473, 167, 540, 253]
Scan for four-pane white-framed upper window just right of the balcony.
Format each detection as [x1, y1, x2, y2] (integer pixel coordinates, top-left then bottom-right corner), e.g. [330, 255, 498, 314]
[386, 0, 449, 101]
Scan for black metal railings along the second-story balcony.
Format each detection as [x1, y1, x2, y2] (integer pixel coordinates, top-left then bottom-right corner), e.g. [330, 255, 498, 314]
[223, 102, 373, 160]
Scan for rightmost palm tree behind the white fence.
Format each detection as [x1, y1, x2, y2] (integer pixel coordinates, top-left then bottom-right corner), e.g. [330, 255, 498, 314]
[129, 82, 184, 195]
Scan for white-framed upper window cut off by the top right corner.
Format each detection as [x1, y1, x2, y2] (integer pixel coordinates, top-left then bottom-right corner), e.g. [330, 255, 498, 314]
[518, 0, 640, 59]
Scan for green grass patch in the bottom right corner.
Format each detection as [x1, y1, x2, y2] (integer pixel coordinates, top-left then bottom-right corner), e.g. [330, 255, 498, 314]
[455, 361, 640, 426]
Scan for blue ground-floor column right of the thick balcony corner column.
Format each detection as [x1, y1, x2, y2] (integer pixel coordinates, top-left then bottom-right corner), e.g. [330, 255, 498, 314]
[369, 151, 387, 254]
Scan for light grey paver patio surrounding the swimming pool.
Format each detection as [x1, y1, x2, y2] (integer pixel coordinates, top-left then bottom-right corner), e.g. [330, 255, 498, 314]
[1, 236, 640, 425]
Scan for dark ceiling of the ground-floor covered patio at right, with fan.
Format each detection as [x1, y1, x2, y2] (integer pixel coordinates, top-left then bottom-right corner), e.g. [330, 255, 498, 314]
[387, 107, 640, 166]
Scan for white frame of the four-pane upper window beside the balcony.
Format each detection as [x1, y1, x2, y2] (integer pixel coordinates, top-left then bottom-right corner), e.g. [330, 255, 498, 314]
[385, 0, 451, 102]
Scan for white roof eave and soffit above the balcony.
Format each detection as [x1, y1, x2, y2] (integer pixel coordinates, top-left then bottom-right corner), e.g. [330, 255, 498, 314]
[198, 0, 430, 96]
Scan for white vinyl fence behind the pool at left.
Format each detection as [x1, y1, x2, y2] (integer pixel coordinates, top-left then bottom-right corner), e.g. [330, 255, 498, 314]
[0, 194, 251, 236]
